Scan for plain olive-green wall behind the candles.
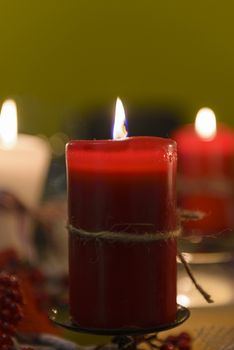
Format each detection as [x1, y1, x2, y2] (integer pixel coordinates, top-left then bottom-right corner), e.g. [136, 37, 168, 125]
[0, 0, 234, 135]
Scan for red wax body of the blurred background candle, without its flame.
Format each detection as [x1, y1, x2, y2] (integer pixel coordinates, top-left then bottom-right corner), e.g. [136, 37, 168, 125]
[173, 125, 234, 235]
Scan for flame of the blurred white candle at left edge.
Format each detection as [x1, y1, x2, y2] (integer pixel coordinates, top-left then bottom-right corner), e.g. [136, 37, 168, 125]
[0, 100, 17, 148]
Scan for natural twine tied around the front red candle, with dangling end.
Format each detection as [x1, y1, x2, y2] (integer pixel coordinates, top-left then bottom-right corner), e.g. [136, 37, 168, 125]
[67, 225, 213, 303]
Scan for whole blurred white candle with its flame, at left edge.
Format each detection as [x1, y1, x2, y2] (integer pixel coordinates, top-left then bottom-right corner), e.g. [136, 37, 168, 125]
[0, 100, 50, 258]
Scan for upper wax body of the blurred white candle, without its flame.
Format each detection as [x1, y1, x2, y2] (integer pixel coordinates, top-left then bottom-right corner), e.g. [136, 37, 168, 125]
[0, 134, 51, 208]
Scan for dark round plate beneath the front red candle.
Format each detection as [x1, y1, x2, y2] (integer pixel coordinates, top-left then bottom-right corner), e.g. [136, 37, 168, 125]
[49, 305, 190, 336]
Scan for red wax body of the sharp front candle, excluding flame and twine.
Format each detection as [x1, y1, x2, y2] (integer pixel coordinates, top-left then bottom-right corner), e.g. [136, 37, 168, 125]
[66, 137, 177, 328]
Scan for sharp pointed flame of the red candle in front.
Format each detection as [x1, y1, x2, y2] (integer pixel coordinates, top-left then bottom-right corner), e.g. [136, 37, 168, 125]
[113, 97, 128, 139]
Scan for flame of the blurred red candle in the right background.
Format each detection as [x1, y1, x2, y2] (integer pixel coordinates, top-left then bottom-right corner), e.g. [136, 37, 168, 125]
[195, 108, 216, 141]
